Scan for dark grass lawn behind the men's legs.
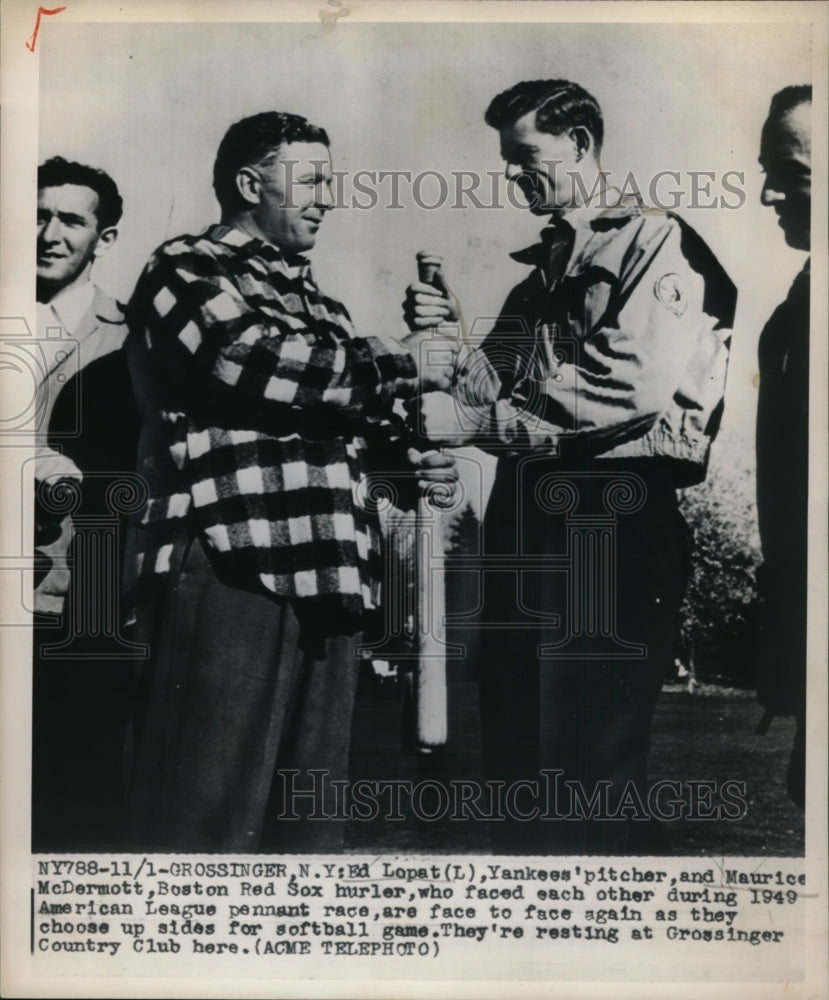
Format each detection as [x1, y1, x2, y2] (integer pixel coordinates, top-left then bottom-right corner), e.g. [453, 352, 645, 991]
[346, 674, 804, 857]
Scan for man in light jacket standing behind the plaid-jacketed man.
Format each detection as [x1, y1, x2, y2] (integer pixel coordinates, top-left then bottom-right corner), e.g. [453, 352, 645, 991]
[32, 157, 137, 850]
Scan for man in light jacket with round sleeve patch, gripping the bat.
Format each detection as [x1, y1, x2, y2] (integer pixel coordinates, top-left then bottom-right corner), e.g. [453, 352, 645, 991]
[405, 80, 736, 854]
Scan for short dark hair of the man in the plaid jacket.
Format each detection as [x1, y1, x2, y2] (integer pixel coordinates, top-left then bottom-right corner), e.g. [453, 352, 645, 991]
[213, 111, 330, 208]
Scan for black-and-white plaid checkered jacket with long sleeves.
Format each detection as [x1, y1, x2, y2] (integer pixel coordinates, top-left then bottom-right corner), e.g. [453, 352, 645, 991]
[127, 226, 416, 622]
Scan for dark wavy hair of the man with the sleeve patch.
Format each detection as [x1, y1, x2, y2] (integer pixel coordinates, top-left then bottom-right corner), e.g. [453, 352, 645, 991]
[484, 80, 604, 152]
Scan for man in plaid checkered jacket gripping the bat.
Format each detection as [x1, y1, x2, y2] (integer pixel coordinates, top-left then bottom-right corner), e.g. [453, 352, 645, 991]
[127, 112, 454, 851]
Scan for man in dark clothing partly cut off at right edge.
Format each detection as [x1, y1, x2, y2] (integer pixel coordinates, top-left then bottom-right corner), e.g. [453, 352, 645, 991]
[757, 86, 812, 808]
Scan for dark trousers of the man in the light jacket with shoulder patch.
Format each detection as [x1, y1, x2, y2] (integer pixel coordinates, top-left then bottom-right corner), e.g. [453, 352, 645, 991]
[480, 463, 688, 853]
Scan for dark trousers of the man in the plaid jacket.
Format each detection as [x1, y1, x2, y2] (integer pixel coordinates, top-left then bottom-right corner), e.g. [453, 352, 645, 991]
[128, 540, 359, 852]
